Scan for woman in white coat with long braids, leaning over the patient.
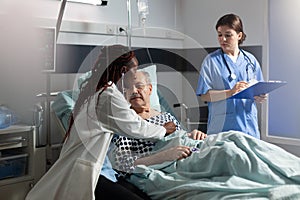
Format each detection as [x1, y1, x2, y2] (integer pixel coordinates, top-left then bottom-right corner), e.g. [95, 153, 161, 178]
[26, 45, 166, 200]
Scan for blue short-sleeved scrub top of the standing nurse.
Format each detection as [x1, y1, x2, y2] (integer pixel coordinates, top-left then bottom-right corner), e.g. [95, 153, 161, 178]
[196, 49, 263, 138]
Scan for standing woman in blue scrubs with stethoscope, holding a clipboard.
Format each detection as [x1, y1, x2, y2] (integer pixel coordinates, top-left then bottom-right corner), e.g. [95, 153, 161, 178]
[196, 14, 267, 138]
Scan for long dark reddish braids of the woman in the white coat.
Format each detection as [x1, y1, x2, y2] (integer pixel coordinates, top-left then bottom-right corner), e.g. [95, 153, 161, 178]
[64, 45, 135, 141]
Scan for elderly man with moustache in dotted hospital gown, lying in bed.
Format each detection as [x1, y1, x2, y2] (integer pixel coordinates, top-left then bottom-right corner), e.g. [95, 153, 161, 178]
[112, 71, 206, 172]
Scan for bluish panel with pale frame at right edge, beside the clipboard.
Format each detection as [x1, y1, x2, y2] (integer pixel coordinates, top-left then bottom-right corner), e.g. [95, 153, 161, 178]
[266, 0, 300, 156]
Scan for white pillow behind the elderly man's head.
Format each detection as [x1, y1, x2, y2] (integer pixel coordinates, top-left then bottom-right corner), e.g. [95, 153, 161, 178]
[138, 65, 161, 112]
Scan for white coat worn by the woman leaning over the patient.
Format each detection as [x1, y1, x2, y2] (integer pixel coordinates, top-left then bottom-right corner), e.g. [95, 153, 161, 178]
[26, 85, 165, 200]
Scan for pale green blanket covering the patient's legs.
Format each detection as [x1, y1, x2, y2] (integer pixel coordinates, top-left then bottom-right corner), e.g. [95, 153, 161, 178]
[129, 131, 300, 200]
